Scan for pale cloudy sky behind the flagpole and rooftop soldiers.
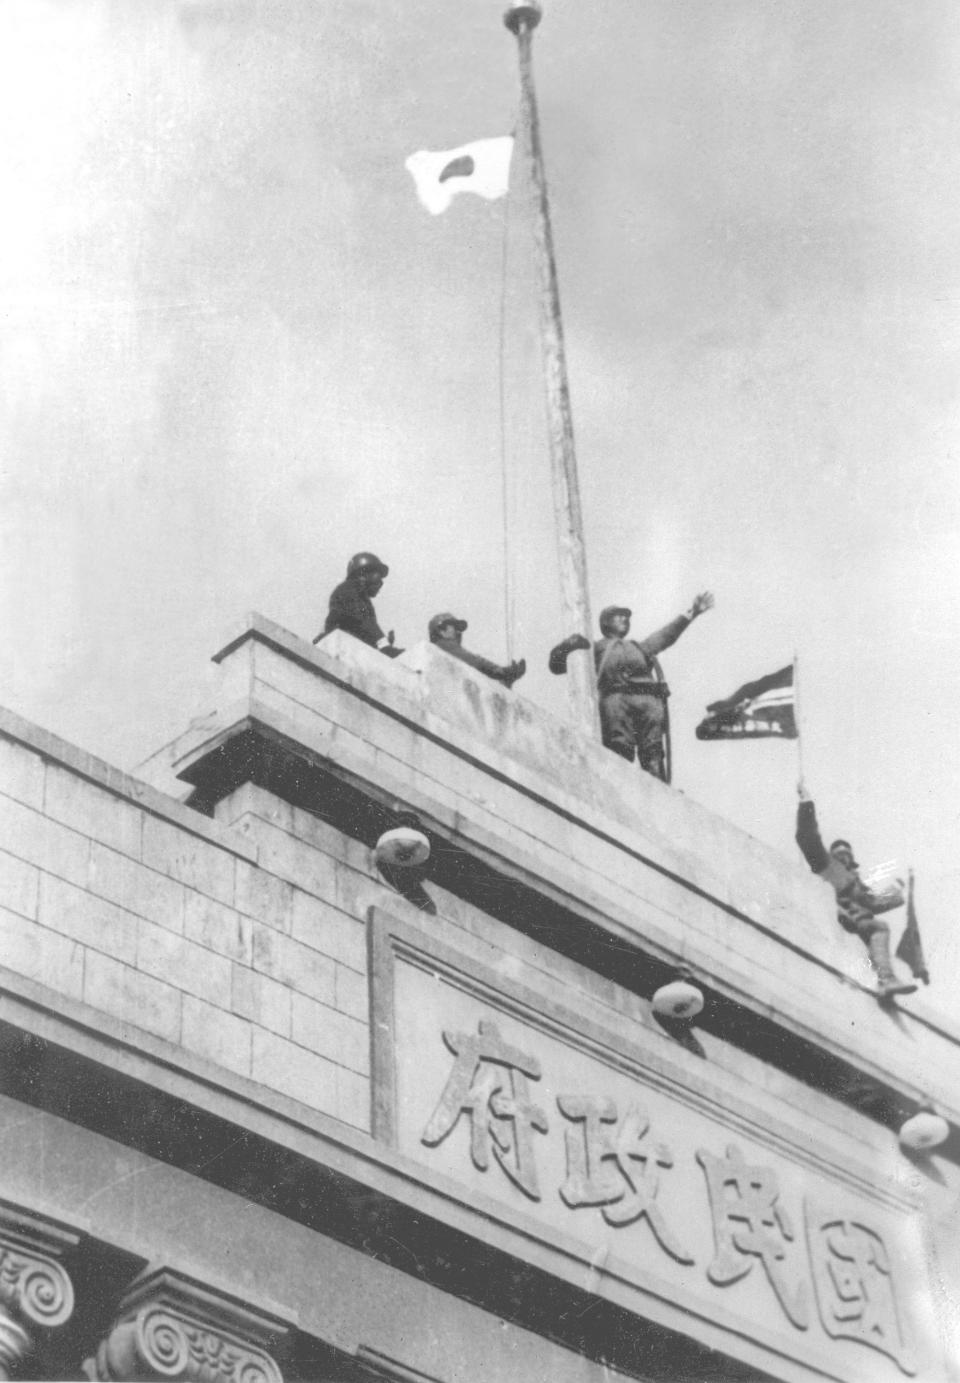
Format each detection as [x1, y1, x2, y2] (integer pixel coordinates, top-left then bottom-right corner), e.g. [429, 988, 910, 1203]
[0, 0, 960, 1014]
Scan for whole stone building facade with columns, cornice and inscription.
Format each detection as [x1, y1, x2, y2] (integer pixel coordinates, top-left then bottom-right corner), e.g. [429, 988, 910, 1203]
[0, 615, 960, 1383]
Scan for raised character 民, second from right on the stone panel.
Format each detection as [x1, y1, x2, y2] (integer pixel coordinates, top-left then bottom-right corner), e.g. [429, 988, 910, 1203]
[697, 1145, 809, 1330]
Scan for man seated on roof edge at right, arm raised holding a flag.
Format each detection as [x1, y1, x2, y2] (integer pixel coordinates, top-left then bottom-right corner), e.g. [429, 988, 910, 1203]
[797, 779, 917, 1004]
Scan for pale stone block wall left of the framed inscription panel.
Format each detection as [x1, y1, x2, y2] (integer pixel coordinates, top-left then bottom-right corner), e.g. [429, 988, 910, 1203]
[0, 715, 375, 1130]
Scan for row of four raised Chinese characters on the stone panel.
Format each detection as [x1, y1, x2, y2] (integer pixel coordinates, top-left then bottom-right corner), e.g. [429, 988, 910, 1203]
[420, 1018, 916, 1373]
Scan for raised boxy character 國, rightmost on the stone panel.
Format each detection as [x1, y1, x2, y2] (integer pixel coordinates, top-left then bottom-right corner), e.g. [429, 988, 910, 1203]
[806, 1203, 916, 1373]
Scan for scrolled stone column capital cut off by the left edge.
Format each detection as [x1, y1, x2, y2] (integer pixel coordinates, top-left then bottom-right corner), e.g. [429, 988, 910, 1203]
[0, 1202, 79, 1380]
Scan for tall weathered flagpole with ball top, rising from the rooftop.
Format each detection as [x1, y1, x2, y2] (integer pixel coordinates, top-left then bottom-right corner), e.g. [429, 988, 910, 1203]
[504, 0, 599, 736]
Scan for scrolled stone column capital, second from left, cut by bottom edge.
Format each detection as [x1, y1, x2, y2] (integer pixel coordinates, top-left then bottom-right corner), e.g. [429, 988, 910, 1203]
[83, 1268, 288, 1383]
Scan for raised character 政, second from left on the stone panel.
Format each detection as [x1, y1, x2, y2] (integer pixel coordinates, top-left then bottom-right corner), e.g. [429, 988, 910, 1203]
[556, 1095, 693, 1263]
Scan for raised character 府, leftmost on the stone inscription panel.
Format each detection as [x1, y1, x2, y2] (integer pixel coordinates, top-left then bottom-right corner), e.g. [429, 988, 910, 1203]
[421, 1019, 548, 1200]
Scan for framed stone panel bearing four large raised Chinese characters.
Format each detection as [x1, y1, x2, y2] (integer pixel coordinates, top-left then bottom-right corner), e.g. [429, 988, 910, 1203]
[378, 928, 946, 1383]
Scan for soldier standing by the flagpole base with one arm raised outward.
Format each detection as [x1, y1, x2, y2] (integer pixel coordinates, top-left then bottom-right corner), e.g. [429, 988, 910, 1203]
[549, 591, 714, 781]
